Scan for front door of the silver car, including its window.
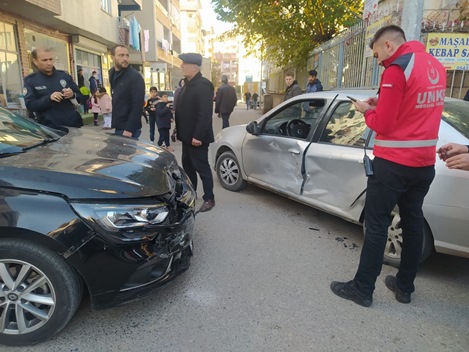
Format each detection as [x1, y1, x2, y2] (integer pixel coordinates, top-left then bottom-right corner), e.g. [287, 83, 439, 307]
[242, 101, 324, 195]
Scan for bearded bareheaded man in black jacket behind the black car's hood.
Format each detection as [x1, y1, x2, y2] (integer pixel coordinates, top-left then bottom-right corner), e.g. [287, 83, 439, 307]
[109, 45, 145, 139]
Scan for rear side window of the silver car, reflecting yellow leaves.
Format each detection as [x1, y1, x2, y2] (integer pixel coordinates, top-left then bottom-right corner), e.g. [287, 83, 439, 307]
[320, 101, 370, 147]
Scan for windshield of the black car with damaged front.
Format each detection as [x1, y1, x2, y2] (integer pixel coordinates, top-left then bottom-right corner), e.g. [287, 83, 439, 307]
[0, 108, 61, 155]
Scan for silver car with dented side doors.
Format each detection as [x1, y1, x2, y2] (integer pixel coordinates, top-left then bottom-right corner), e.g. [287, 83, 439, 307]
[211, 90, 469, 266]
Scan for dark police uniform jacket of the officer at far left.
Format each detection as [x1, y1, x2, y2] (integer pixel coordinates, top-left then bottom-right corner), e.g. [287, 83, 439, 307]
[24, 68, 86, 129]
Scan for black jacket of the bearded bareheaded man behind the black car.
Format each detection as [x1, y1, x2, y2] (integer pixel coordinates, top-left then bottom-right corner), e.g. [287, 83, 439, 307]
[109, 66, 145, 133]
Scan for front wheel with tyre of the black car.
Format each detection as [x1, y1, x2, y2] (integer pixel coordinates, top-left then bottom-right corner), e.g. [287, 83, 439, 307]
[0, 239, 82, 346]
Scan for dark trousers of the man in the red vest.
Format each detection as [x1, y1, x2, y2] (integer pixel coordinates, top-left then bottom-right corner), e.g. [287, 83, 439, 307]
[354, 157, 435, 296]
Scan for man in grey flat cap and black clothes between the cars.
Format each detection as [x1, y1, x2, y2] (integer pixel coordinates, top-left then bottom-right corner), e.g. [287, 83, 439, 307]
[176, 53, 215, 212]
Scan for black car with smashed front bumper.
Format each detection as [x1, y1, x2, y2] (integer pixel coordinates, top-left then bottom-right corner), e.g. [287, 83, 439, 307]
[0, 108, 195, 345]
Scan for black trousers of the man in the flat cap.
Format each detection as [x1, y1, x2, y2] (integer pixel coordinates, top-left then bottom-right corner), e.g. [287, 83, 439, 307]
[181, 143, 215, 200]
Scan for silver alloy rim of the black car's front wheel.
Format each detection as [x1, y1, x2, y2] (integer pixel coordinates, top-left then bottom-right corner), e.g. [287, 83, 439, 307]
[0, 259, 56, 335]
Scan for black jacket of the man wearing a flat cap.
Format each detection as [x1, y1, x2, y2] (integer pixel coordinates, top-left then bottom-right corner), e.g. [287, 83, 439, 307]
[176, 72, 214, 145]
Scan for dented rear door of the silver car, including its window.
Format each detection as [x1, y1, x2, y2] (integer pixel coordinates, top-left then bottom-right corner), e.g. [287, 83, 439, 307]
[302, 101, 372, 221]
